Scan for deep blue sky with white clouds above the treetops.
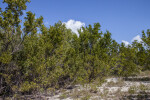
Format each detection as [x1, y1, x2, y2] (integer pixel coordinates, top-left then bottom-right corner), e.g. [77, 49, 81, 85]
[0, 0, 150, 44]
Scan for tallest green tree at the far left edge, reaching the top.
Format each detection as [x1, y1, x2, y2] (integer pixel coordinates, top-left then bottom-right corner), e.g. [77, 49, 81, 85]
[0, 0, 29, 95]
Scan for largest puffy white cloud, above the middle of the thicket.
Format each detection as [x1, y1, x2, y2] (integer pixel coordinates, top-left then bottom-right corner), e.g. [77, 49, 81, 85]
[63, 19, 85, 36]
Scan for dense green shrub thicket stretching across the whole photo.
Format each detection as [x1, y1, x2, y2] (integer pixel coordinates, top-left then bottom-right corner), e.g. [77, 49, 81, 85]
[0, 0, 150, 96]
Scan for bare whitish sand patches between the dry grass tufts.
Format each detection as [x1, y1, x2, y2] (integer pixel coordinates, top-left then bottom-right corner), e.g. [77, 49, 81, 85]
[48, 78, 150, 100]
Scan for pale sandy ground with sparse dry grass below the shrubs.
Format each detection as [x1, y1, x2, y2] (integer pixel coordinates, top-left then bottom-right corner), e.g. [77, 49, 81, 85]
[0, 76, 150, 100]
